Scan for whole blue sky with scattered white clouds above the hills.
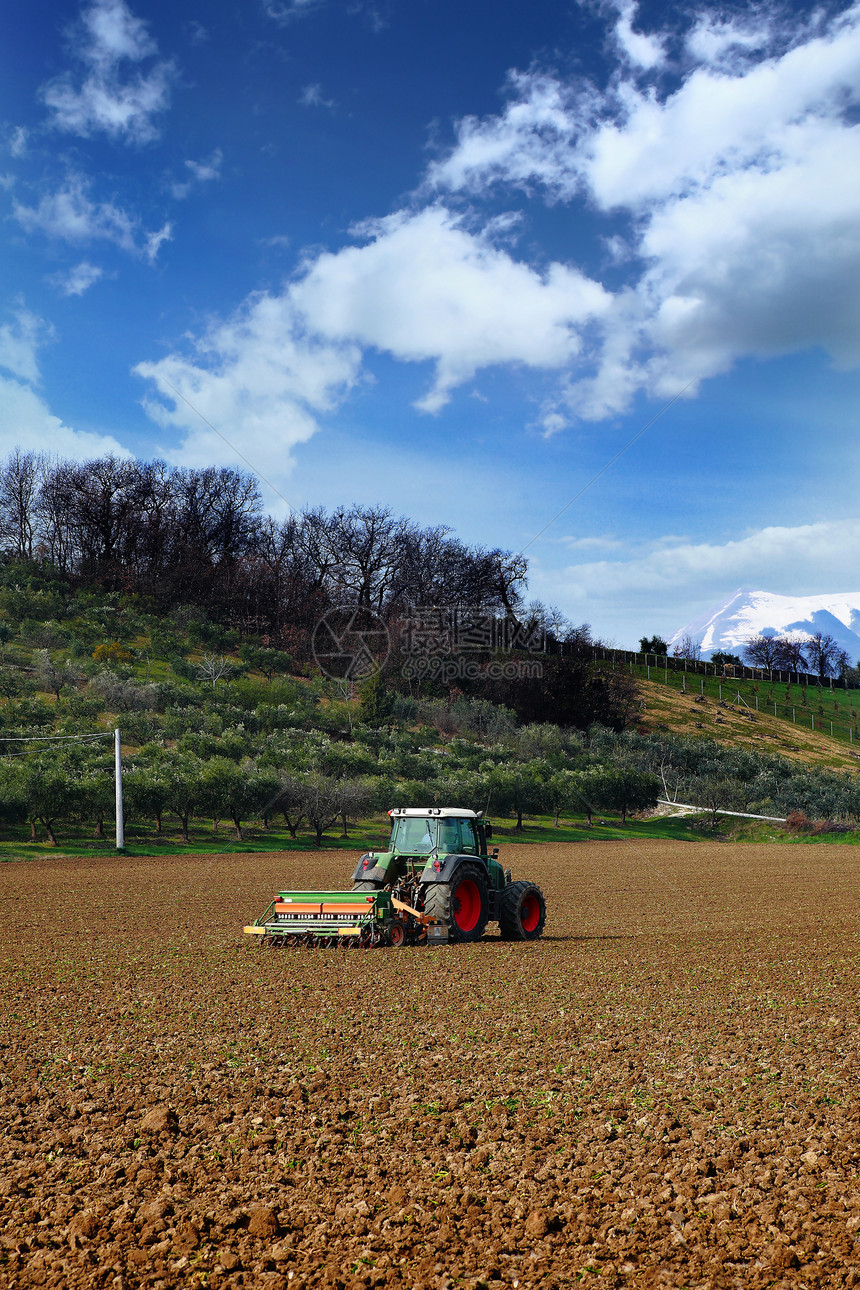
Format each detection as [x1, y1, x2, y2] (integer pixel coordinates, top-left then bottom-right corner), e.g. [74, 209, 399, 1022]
[0, 0, 860, 646]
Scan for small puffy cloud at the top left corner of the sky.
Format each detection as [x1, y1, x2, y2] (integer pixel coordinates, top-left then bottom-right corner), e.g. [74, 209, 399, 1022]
[41, 0, 174, 143]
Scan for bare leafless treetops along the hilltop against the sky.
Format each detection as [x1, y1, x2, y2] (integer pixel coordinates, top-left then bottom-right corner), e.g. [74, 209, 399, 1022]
[0, 449, 527, 636]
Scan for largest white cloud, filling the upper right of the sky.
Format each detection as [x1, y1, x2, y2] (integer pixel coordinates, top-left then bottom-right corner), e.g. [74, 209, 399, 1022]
[428, 4, 860, 418]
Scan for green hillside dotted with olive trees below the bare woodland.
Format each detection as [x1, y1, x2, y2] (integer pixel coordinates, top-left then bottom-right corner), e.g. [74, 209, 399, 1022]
[0, 554, 860, 855]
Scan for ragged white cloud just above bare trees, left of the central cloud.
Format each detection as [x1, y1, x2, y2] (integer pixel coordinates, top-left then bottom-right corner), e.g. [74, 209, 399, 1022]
[134, 294, 360, 485]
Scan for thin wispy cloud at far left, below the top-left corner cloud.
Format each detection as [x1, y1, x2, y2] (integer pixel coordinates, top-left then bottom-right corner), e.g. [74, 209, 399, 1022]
[13, 174, 171, 261]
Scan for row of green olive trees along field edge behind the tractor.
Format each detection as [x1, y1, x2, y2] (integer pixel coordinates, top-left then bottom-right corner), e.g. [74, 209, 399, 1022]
[0, 725, 660, 845]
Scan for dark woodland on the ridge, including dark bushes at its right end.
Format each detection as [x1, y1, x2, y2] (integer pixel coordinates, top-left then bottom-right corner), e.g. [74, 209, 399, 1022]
[0, 450, 636, 729]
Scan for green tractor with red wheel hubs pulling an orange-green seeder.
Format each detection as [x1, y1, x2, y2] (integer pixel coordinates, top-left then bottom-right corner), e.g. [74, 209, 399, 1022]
[245, 806, 547, 947]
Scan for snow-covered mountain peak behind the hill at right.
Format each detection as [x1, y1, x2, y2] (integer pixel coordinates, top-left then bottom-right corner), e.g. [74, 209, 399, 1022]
[669, 590, 860, 663]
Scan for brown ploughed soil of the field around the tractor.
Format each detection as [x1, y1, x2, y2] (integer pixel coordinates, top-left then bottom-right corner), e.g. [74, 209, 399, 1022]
[0, 842, 860, 1290]
